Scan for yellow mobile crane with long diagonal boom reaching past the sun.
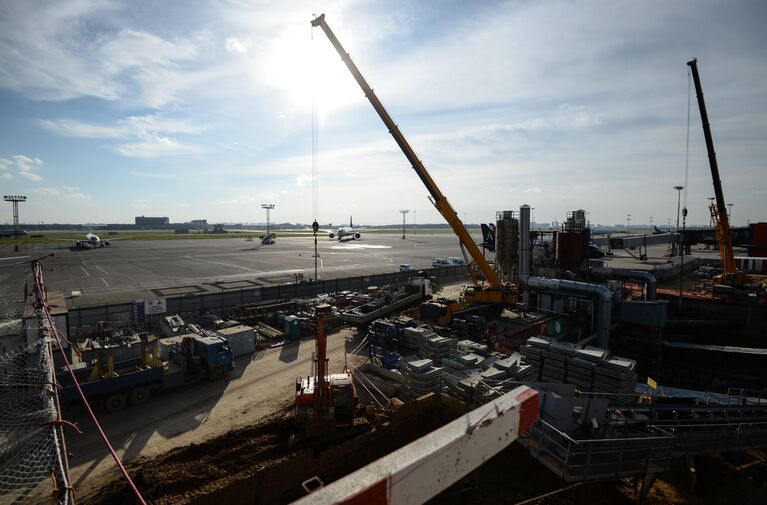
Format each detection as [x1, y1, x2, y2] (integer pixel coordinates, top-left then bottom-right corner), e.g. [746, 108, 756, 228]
[312, 14, 517, 303]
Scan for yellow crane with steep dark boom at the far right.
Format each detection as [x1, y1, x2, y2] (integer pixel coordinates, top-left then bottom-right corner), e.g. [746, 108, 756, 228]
[687, 58, 766, 288]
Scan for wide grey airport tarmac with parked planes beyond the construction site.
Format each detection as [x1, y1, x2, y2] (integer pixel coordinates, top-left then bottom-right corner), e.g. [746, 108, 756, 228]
[0, 233, 492, 308]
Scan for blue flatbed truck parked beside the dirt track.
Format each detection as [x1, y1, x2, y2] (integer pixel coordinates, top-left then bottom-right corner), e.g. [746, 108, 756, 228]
[57, 335, 234, 412]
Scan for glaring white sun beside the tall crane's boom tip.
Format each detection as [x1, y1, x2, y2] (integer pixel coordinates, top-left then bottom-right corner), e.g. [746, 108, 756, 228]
[264, 23, 364, 114]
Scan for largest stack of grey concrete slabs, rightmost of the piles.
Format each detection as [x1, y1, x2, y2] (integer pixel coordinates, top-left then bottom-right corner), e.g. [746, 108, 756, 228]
[519, 337, 637, 400]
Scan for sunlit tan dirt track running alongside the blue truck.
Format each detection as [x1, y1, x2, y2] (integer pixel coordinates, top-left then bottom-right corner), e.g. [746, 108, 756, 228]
[65, 329, 366, 501]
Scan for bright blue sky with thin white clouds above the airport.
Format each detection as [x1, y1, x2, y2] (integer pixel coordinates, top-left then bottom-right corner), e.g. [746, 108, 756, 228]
[0, 0, 767, 225]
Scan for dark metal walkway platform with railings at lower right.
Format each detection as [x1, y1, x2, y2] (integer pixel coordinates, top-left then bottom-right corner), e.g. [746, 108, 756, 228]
[520, 395, 767, 482]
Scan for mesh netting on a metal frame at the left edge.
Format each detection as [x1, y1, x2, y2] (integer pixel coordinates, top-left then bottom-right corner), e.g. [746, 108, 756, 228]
[0, 279, 71, 504]
